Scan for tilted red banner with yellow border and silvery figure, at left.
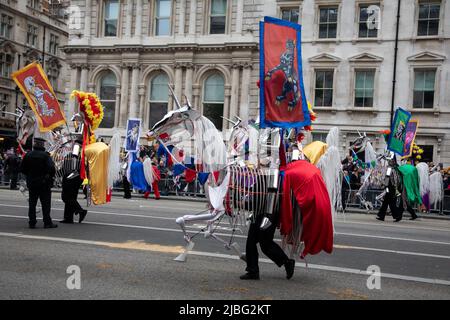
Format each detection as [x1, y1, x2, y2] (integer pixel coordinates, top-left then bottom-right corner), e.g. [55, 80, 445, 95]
[12, 62, 66, 132]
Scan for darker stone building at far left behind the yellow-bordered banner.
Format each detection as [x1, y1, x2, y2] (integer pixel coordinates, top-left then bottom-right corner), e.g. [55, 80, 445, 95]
[0, 0, 68, 147]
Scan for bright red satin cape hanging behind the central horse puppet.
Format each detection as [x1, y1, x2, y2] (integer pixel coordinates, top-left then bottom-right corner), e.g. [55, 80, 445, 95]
[280, 160, 333, 258]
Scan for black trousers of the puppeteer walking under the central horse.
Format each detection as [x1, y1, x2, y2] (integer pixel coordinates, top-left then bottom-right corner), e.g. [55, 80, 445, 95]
[245, 217, 289, 273]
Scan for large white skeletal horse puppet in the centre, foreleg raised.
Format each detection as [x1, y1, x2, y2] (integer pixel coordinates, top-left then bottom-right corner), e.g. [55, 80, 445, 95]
[146, 88, 276, 262]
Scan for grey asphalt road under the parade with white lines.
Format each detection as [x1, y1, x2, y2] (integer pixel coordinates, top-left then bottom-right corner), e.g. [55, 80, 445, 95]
[0, 190, 450, 300]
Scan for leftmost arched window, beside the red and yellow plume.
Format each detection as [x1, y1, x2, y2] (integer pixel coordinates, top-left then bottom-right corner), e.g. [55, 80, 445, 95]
[99, 71, 117, 128]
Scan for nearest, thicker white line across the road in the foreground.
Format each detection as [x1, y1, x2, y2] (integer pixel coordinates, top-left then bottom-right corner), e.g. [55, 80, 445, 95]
[0, 232, 450, 286]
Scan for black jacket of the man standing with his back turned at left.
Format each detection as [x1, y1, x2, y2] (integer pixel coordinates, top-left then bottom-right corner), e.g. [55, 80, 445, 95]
[20, 148, 55, 189]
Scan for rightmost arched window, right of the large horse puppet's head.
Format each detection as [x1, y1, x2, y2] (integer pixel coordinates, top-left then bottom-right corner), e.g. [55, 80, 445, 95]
[203, 73, 225, 130]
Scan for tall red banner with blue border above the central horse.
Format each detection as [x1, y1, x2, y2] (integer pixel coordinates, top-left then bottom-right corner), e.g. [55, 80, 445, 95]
[260, 17, 311, 128]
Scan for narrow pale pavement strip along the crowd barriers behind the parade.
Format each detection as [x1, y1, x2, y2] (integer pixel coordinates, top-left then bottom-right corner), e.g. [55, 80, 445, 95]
[0, 185, 450, 221]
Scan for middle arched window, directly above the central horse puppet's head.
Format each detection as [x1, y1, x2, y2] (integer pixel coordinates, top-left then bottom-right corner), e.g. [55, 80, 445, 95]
[148, 73, 169, 128]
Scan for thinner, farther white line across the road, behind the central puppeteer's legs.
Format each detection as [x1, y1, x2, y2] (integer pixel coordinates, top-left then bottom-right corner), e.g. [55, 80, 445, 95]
[0, 215, 450, 259]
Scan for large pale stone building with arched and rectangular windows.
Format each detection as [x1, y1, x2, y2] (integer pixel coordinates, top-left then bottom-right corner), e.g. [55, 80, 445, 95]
[64, 0, 450, 165]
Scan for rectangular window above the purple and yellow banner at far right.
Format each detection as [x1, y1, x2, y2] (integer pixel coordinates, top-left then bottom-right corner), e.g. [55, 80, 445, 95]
[413, 70, 436, 108]
